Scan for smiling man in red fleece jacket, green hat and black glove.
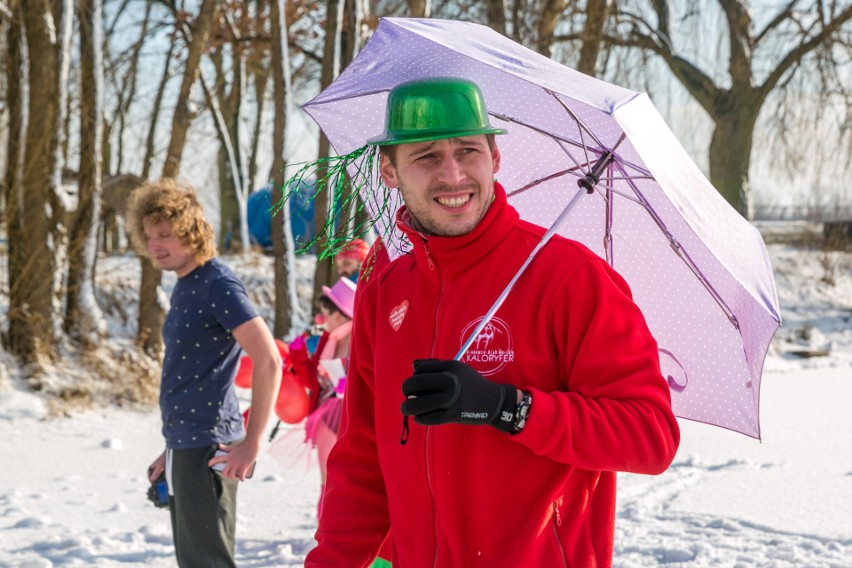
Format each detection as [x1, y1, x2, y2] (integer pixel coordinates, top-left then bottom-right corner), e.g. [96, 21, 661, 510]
[306, 79, 679, 568]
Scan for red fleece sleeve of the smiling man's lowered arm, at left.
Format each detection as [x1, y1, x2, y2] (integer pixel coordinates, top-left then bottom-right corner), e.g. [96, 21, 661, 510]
[305, 284, 390, 568]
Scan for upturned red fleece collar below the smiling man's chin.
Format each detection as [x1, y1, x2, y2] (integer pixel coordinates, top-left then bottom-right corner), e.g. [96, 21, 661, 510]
[396, 181, 520, 274]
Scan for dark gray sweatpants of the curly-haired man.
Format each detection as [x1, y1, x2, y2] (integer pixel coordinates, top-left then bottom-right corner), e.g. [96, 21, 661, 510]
[169, 446, 239, 568]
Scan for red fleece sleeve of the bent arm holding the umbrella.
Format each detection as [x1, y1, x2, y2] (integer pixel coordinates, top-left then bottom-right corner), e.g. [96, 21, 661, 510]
[514, 255, 680, 474]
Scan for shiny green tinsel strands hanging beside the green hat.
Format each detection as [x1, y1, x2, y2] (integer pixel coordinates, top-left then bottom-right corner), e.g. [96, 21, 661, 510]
[271, 145, 396, 260]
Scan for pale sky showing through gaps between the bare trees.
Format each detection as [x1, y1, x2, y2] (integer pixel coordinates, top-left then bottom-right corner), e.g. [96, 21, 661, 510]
[90, 2, 852, 222]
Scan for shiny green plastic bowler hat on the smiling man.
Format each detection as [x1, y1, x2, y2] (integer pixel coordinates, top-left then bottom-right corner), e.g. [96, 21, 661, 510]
[367, 78, 506, 146]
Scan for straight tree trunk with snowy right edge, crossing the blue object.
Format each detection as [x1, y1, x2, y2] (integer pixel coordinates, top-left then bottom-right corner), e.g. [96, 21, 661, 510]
[269, 0, 296, 337]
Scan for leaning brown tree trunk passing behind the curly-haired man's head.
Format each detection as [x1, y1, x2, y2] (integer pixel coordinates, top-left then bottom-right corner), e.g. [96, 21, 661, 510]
[137, 0, 219, 358]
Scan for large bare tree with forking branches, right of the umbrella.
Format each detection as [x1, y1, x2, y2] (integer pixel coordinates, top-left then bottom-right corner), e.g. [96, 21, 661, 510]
[606, 0, 852, 215]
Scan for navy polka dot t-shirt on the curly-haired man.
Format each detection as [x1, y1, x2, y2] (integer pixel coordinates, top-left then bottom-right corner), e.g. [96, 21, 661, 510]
[160, 258, 258, 450]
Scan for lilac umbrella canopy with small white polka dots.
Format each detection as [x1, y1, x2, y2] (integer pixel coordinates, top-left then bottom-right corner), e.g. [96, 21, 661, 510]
[304, 18, 780, 438]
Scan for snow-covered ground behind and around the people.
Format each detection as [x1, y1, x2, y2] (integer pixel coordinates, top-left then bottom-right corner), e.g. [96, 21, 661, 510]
[0, 239, 852, 568]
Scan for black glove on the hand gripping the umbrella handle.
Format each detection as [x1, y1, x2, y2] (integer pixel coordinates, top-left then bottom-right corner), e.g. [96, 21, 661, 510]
[401, 359, 518, 432]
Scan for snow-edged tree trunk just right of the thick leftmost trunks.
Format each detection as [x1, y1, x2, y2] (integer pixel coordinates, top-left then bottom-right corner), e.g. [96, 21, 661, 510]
[65, 0, 106, 347]
